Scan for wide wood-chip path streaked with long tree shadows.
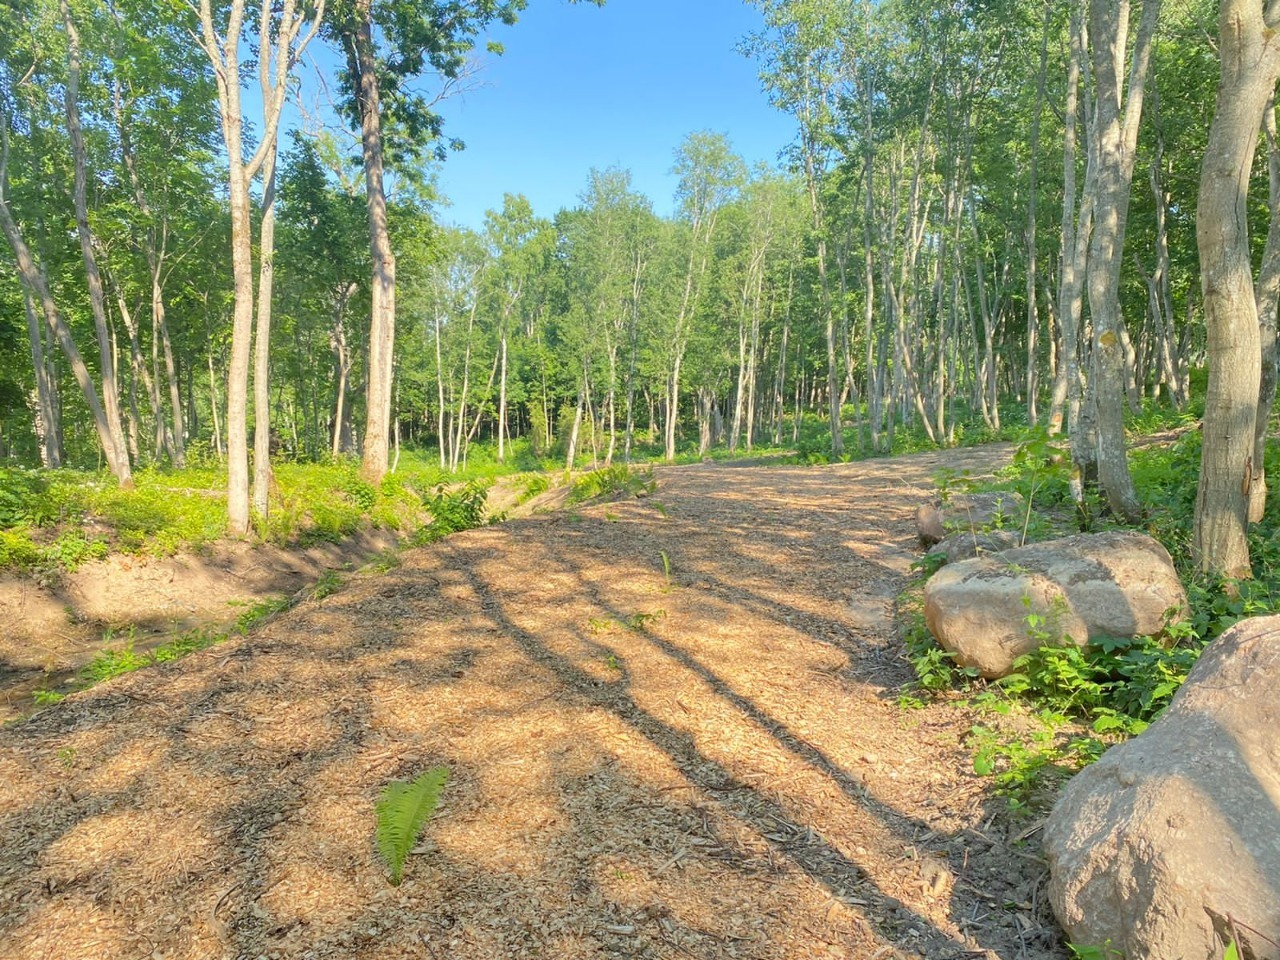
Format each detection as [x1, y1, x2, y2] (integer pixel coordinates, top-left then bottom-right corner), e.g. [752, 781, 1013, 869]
[0, 448, 1065, 960]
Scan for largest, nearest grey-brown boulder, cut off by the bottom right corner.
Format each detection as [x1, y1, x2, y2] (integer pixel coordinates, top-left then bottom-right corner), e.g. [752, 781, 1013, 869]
[1044, 617, 1280, 960]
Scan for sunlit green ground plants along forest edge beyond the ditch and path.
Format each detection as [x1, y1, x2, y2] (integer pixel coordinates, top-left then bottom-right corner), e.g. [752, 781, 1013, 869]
[0, 396, 1039, 570]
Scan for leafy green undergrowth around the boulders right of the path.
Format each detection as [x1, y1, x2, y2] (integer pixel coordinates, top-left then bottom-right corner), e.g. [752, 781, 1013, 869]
[899, 394, 1280, 812]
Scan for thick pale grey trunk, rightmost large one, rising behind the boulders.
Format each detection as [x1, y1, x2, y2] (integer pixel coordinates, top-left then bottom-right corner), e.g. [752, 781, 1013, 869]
[1192, 0, 1280, 577]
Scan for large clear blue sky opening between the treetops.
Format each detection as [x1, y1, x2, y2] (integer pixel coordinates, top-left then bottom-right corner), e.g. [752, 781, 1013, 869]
[422, 0, 794, 227]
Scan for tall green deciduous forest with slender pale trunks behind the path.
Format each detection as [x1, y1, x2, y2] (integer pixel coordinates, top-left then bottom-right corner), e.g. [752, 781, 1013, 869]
[0, 0, 1280, 576]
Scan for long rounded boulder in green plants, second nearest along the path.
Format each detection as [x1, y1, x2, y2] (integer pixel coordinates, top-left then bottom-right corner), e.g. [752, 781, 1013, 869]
[924, 532, 1187, 677]
